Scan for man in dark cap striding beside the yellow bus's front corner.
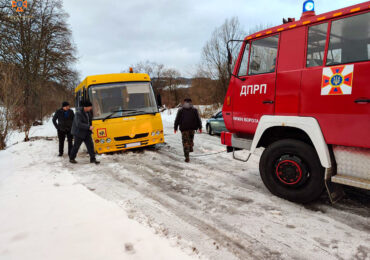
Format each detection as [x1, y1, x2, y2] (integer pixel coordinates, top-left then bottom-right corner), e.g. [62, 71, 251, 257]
[69, 101, 100, 164]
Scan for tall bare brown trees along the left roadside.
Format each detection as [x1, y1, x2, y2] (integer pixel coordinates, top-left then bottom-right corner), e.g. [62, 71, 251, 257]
[0, 0, 78, 149]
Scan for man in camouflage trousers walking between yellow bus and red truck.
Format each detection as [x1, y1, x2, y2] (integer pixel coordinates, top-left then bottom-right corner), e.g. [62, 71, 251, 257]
[175, 98, 202, 162]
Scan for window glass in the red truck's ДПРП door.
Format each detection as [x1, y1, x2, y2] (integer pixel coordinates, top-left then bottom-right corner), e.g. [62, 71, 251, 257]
[248, 35, 279, 75]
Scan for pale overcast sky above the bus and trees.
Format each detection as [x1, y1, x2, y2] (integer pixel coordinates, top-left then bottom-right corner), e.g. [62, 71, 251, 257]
[64, 0, 364, 78]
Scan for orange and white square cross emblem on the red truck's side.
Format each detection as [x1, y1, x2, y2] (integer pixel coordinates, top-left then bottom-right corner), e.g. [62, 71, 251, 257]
[321, 65, 354, 96]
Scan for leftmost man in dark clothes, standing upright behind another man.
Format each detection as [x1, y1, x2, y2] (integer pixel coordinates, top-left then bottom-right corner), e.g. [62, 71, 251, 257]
[53, 101, 74, 156]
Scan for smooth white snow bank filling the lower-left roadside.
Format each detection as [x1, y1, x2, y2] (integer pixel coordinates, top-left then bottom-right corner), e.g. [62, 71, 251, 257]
[0, 140, 197, 259]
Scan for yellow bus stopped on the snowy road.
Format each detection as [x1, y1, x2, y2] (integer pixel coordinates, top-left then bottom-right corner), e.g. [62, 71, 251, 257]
[75, 73, 164, 154]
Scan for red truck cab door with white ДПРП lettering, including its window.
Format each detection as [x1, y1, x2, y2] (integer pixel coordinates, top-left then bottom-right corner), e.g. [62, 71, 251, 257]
[233, 35, 279, 134]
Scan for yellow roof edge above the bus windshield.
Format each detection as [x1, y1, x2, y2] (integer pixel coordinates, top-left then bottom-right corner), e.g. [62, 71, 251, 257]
[75, 73, 150, 92]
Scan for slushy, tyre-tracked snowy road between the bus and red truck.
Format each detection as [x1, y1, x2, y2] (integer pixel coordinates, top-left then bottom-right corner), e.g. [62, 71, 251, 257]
[2, 112, 370, 260]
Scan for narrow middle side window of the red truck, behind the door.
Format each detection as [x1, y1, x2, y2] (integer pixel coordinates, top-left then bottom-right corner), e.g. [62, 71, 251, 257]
[307, 23, 328, 68]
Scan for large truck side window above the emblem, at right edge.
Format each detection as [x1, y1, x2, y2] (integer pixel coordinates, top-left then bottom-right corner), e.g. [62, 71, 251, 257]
[326, 12, 370, 65]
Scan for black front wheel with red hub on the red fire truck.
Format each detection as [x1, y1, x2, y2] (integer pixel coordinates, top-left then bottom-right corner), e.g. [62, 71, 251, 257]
[259, 139, 325, 203]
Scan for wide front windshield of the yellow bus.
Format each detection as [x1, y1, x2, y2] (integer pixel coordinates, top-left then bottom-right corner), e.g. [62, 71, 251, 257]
[89, 82, 158, 119]
